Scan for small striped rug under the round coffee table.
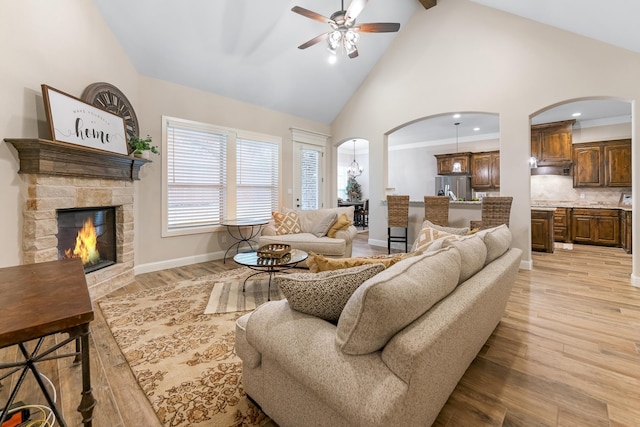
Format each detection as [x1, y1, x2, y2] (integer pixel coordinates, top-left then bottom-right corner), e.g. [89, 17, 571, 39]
[204, 273, 282, 314]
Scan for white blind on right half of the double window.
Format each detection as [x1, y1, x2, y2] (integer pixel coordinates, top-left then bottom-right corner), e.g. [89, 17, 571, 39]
[236, 136, 280, 219]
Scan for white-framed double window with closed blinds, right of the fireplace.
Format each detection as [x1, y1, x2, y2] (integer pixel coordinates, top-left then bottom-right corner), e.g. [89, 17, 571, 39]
[163, 117, 281, 236]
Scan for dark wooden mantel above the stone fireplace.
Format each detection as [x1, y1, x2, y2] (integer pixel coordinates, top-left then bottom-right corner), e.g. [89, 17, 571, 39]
[5, 138, 151, 181]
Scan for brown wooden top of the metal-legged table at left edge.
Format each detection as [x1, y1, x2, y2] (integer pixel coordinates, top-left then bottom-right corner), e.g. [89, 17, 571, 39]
[0, 259, 93, 348]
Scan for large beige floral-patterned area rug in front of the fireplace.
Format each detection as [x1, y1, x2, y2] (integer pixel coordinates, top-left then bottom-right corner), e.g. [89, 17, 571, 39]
[98, 268, 273, 427]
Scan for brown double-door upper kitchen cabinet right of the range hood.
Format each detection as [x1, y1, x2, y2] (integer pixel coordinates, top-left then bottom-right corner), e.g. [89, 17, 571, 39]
[573, 139, 631, 188]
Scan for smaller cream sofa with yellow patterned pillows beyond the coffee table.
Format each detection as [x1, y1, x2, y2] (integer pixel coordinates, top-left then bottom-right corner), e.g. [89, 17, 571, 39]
[258, 206, 358, 258]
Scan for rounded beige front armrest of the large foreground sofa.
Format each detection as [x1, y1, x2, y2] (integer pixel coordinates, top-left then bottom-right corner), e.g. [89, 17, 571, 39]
[246, 300, 408, 425]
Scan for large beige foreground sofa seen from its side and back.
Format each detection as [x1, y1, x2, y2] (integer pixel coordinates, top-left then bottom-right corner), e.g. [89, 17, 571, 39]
[236, 226, 522, 427]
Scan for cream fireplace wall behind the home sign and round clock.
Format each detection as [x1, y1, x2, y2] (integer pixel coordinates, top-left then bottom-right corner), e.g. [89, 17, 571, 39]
[0, 0, 139, 267]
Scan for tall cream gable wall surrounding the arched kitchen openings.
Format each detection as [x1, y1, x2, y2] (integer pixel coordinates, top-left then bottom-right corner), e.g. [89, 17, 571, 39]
[332, 0, 640, 277]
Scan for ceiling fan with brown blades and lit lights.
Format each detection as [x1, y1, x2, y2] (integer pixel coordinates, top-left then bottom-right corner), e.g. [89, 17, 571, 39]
[291, 0, 400, 58]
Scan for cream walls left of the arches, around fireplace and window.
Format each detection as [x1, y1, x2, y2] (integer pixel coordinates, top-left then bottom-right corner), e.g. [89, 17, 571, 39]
[0, 0, 334, 273]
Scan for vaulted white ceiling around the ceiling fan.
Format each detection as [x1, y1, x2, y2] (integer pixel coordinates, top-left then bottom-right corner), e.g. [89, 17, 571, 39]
[93, 0, 640, 132]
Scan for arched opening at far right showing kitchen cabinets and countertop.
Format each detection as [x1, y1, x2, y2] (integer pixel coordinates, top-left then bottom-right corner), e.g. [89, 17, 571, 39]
[531, 98, 633, 252]
